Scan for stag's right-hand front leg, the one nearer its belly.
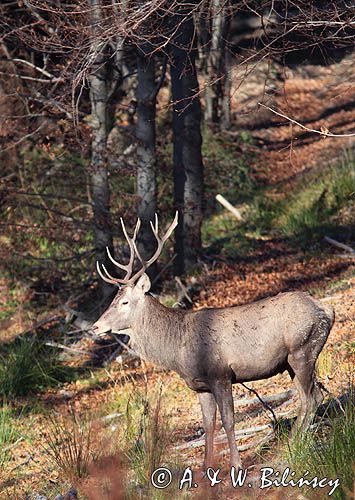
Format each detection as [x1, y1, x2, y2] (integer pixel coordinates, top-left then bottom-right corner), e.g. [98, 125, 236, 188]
[213, 380, 242, 470]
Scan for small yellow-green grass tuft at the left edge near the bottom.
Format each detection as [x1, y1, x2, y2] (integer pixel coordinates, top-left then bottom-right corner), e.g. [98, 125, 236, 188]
[0, 403, 21, 470]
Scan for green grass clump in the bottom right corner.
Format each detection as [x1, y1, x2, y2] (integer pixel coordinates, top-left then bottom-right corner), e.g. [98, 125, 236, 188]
[287, 394, 355, 499]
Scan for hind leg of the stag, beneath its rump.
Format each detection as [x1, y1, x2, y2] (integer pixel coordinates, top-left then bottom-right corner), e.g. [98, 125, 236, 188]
[288, 350, 323, 432]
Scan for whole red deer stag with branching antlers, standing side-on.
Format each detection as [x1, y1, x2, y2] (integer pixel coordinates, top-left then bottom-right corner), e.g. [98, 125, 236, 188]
[93, 214, 334, 469]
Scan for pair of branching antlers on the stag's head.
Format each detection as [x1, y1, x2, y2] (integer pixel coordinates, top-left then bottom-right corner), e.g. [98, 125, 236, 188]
[96, 211, 178, 285]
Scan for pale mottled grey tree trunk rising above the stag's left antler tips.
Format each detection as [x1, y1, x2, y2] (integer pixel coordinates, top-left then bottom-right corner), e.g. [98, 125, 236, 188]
[88, 0, 113, 297]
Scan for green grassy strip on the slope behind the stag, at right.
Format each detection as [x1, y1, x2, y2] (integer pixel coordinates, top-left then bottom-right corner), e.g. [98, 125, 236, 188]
[202, 148, 355, 259]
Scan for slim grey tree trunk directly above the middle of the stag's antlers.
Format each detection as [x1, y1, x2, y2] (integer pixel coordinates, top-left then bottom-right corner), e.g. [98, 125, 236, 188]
[136, 44, 157, 278]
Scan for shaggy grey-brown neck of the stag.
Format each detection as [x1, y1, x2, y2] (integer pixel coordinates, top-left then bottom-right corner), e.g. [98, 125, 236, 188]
[131, 295, 184, 370]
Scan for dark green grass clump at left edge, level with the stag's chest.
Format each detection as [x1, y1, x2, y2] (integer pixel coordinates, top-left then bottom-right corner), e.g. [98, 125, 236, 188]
[0, 337, 73, 398]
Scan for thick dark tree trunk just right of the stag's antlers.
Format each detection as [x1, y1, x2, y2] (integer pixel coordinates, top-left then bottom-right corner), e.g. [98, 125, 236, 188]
[170, 5, 203, 275]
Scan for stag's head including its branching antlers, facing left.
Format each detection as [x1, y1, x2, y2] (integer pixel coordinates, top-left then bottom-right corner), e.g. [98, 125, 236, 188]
[92, 212, 178, 335]
